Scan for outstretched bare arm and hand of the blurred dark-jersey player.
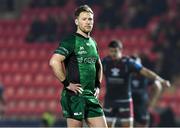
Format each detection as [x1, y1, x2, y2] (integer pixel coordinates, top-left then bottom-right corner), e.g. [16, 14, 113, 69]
[140, 67, 171, 87]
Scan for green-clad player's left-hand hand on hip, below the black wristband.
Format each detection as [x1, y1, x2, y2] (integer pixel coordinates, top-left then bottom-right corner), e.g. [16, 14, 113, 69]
[66, 83, 83, 94]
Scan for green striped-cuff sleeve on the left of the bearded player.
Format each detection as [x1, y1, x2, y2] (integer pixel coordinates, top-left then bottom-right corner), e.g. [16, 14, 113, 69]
[54, 40, 74, 57]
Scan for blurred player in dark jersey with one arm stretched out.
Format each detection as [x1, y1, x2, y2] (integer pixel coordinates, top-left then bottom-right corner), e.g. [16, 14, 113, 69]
[102, 41, 170, 127]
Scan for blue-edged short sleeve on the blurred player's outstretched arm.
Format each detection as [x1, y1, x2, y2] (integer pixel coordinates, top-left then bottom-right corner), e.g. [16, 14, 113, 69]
[128, 59, 143, 72]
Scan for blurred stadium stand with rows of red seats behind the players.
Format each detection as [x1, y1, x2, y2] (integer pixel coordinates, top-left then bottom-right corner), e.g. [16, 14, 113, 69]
[0, 0, 180, 126]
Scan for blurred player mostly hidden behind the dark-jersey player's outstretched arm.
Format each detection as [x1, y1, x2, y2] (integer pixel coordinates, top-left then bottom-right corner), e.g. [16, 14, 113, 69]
[131, 56, 162, 127]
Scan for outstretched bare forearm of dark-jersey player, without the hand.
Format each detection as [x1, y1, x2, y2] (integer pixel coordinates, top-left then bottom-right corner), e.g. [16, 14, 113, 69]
[140, 68, 164, 82]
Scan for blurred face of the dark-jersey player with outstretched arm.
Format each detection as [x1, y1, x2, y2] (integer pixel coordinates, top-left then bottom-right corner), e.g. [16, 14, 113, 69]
[109, 48, 122, 59]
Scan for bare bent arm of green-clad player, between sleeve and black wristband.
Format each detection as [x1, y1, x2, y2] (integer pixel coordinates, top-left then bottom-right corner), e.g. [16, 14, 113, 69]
[49, 59, 65, 81]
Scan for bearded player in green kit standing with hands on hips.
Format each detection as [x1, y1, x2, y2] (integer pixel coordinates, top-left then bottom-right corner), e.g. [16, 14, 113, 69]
[50, 5, 107, 127]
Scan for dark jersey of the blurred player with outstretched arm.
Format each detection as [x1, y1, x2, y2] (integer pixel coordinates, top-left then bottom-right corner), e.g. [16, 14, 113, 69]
[102, 57, 142, 107]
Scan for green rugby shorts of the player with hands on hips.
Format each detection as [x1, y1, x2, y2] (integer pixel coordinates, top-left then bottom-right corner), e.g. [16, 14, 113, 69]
[61, 90, 104, 121]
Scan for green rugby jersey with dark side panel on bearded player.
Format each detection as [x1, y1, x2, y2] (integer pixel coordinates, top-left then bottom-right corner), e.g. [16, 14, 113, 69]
[55, 33, 99, 92]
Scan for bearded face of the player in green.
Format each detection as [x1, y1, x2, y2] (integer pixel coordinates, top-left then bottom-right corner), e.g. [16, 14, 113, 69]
[75, 12, 94, 33]
